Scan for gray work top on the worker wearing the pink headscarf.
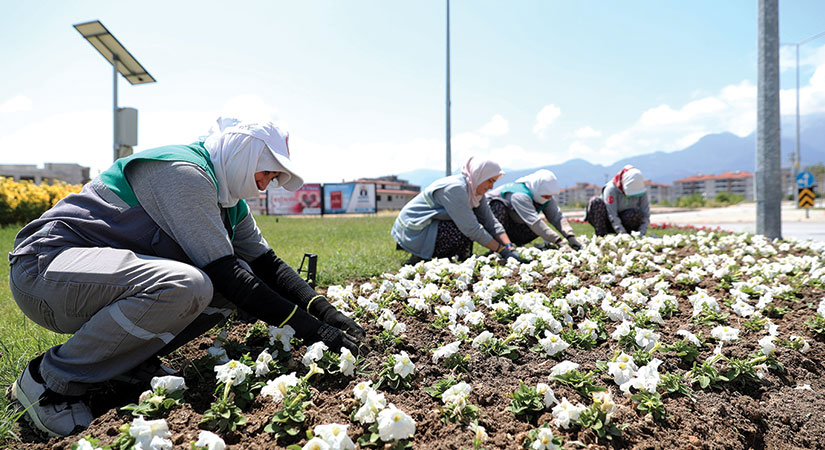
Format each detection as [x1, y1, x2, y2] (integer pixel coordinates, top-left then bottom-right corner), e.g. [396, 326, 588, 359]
[390, 175, 504, 259]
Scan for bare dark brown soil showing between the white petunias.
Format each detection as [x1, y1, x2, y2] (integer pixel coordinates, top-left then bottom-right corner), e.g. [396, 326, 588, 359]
[6, 236, 825, 450]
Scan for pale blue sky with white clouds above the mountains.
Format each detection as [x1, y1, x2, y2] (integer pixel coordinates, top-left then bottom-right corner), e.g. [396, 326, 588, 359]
[0, 0, 825, 182]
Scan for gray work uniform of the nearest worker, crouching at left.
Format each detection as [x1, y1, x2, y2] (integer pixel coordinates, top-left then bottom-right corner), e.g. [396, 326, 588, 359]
[9, 160, 269, 395]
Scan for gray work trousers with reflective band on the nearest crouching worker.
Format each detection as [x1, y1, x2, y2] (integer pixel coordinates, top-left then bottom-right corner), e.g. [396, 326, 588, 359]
[9, 247, 237, 395]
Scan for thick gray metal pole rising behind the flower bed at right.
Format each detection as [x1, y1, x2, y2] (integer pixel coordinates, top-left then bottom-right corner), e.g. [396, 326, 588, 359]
[754, 0, 782, 239]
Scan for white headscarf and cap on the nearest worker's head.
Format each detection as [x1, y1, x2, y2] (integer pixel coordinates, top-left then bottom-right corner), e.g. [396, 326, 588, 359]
[203, 117, 303, 208]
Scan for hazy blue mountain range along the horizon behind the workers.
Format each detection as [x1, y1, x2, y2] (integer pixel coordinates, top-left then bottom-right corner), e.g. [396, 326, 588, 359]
[398, 113, 825, 187]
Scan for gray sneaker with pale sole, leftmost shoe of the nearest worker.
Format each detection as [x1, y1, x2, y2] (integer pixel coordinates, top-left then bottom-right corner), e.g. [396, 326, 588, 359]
[10, 355, 94, 436]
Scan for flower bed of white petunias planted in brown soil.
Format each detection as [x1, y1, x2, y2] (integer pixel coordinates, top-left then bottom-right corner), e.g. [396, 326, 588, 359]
[11, 231, 825, 449]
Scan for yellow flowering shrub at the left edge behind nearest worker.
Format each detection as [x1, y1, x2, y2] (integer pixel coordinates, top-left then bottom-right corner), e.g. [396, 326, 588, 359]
[0, 177, 82, 225]
